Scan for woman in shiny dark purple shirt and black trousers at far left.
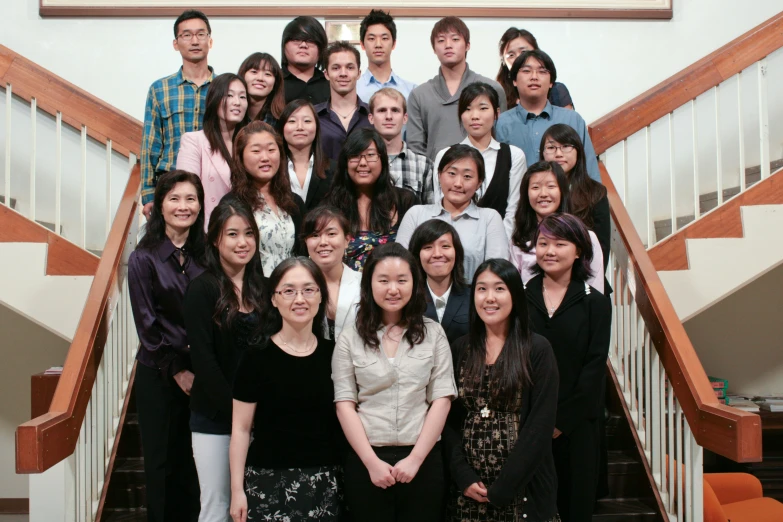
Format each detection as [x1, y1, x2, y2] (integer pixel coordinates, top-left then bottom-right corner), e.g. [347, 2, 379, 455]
[128, 170, 204, 521]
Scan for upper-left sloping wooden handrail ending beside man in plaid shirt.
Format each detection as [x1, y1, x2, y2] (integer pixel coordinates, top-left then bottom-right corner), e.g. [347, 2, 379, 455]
[0, 45, 142, 156]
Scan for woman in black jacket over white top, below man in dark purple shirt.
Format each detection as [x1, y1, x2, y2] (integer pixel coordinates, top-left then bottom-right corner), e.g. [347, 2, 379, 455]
[275, 100, 332, 211]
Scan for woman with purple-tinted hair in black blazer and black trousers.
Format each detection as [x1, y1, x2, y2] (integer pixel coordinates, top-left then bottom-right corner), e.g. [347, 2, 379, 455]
[527, 214, 612, 522]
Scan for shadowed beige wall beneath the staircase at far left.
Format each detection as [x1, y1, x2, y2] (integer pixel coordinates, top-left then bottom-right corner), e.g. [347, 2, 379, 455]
[0, 305, 68, 498]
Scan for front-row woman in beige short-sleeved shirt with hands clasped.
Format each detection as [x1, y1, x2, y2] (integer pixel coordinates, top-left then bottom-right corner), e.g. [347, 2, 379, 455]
[332, 243, 457, 522]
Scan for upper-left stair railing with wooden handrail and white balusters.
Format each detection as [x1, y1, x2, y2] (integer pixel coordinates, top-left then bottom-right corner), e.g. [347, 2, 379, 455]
[0, 45, 142, 250]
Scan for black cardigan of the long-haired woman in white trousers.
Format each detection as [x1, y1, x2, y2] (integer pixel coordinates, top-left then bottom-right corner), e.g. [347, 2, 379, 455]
[184, 271, 262, 429]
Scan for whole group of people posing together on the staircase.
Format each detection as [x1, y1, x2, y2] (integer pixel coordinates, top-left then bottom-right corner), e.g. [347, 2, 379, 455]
[128, 10, 611, 522]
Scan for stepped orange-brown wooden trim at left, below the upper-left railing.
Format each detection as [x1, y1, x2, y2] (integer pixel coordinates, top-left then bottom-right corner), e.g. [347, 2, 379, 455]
[0, 205, 99, 276]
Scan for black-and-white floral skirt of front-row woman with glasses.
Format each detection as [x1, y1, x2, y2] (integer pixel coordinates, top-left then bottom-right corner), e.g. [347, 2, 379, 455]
[245, 466, 343, 522]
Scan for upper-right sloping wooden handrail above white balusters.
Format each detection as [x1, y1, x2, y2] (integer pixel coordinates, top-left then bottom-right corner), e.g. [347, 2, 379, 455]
[590, 12, 783, 154]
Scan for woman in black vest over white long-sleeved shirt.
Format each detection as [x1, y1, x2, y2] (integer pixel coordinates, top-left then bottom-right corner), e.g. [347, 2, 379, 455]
[434, 82, 527, 236]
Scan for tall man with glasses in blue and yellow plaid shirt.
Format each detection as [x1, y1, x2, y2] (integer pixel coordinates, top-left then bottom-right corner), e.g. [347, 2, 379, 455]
[141, 10, 215, 219]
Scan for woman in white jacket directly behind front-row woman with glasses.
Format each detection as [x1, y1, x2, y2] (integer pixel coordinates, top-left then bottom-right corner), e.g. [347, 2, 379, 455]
[302, 206, 362, 340]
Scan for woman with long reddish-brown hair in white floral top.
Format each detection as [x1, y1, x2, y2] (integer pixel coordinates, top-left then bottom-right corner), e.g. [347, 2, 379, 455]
[231, 120, 305, 275]
